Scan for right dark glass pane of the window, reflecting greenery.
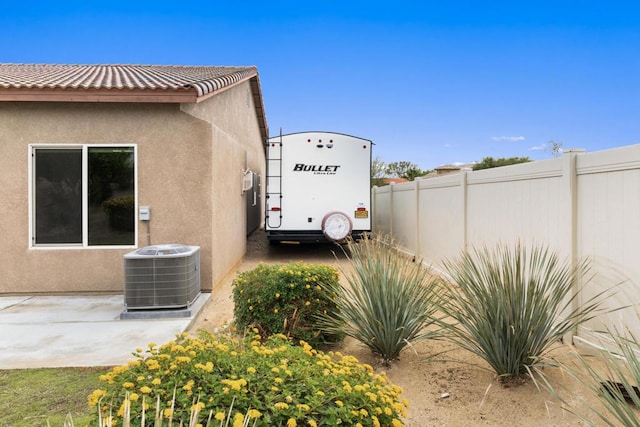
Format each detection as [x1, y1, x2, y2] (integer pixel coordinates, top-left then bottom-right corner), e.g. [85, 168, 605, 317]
[87, 147, 135, 246]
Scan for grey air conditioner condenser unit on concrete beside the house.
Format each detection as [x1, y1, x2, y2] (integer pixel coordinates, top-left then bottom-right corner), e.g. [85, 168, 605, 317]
[124, 244, 200, 310]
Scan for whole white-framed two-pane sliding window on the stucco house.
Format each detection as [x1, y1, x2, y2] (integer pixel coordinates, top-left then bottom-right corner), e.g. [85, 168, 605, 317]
[29, 144, 137, 248]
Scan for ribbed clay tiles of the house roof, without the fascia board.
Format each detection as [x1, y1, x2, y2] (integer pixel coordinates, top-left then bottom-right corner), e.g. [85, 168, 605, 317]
[0, 64, 258, 97]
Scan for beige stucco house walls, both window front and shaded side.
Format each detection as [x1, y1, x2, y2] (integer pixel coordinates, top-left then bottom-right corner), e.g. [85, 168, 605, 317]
[0, 65, 265, 294]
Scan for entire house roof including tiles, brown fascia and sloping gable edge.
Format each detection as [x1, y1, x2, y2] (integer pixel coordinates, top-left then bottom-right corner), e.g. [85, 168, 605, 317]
[0, 63, 268, 139]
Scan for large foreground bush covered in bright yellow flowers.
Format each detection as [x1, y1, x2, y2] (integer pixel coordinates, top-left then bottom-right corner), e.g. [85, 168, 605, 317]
[89, 332, 408, 427]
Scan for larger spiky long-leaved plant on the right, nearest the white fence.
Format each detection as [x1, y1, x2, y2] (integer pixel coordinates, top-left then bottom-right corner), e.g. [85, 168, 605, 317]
[443, 243, 604, 378]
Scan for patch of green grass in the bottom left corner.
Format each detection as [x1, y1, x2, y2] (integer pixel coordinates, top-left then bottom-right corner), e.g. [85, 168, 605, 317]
[0, 368, 107, 427]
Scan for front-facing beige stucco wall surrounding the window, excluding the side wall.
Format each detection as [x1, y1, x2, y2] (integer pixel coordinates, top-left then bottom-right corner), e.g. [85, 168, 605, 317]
[0, 103, 212, 293]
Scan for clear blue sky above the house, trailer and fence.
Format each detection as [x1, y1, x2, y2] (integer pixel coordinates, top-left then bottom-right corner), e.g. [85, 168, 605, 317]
[0, 0, 640, 169]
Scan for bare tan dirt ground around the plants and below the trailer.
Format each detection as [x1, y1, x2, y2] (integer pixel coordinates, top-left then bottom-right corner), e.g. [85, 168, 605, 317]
[190, 231, 594, 427]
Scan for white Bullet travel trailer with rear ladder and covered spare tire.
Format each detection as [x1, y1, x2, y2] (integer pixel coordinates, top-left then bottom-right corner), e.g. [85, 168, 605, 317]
[265, 132, 373, 244]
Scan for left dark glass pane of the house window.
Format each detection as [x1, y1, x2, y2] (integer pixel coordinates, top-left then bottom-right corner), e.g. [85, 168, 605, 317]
[34, 149, 82, 244]
